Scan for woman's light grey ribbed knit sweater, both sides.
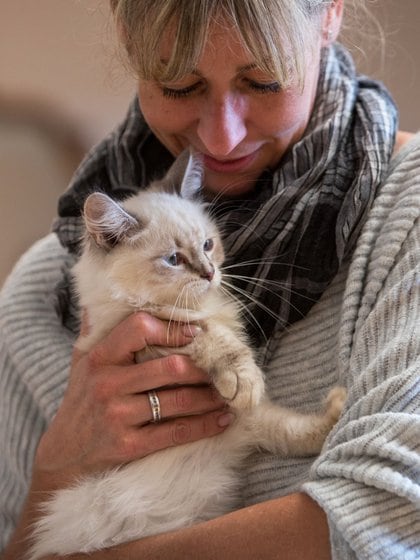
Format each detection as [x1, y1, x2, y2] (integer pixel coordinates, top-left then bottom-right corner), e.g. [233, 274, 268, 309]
[0, 135, 420, 560]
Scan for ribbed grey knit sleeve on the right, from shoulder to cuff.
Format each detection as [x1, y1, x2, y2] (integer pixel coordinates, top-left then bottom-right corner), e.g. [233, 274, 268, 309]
[304, 137, 420, 560]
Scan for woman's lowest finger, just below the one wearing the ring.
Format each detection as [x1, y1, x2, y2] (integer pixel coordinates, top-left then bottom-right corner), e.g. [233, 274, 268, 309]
[115, 410, 235, 463]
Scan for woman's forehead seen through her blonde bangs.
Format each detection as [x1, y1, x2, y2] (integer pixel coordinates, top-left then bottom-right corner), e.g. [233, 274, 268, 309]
[127, 3, 316, 87]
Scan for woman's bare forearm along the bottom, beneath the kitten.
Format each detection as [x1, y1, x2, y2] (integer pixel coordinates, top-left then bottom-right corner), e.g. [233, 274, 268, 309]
[42, 494, 331, 560]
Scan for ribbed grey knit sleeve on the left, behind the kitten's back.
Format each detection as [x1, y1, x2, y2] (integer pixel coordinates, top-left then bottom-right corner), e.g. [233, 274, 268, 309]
[0, 234, 72, 551]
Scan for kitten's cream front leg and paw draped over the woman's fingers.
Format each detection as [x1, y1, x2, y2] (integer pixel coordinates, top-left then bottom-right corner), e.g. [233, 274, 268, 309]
[191, 326, 265, 410]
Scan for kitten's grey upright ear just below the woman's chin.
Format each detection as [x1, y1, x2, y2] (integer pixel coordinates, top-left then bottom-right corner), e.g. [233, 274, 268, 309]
[160, 149, 203, 200]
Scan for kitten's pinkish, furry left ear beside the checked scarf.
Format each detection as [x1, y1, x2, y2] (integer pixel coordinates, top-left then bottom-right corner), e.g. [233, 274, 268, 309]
[83, 192, 140, 250]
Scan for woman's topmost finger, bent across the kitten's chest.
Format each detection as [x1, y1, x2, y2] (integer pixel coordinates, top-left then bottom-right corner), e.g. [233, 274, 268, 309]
[85, 312, 198, 365]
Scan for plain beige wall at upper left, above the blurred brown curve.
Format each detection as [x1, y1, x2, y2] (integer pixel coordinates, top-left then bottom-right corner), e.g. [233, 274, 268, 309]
[0, 0, 131, 148]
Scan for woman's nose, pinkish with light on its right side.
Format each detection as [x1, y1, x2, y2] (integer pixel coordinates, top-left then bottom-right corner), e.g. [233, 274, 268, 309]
[197, 94, 247, 158]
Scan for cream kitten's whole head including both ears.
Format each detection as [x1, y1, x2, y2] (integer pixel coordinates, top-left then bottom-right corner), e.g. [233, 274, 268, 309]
[78, 152, 224, 310]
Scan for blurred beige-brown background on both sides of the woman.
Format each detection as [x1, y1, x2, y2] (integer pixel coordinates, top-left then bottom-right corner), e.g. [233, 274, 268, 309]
[0, 0, 420, 284]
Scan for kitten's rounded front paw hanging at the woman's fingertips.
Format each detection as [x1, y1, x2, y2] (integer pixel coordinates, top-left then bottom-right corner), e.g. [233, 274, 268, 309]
[214, 366, 265, 410]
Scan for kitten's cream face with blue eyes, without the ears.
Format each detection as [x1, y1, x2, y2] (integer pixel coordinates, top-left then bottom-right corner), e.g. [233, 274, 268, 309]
[102, 193, 224, 309]
